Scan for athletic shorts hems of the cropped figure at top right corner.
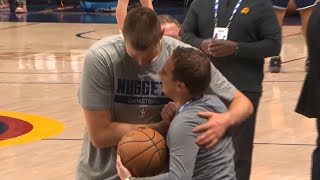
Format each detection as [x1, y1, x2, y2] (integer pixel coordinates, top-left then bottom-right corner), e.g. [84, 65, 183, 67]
[271, 0, 318, 11]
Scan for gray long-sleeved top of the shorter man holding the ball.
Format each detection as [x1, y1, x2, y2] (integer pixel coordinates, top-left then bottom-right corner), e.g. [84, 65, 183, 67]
[133, 95, 236, 180]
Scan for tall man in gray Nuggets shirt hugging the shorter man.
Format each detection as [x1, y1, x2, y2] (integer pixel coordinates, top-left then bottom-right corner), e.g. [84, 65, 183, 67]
[76, 7, 252, 180]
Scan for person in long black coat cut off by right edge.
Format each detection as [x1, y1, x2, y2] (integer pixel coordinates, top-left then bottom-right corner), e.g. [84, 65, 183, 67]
[296, 3, 320, 180]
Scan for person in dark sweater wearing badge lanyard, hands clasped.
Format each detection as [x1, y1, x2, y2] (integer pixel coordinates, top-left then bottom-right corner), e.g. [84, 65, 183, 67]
[182, 0, 281, 180]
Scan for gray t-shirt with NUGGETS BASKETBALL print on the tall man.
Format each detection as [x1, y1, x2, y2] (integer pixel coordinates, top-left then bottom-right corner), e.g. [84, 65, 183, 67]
[77, 35, 235, 180]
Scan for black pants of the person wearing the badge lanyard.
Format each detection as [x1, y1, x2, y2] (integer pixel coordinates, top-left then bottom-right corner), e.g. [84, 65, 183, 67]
[232, 92, 262, 180]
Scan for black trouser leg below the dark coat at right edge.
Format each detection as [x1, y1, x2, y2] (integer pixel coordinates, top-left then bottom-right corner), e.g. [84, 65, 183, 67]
[311, 118, 320, 180]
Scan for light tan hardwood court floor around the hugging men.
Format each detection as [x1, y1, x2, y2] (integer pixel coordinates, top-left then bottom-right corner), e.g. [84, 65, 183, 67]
[0, 22, 316, 180]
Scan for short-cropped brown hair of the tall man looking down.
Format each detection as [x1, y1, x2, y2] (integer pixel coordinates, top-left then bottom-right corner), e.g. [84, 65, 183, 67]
[122, 7, 162, 51]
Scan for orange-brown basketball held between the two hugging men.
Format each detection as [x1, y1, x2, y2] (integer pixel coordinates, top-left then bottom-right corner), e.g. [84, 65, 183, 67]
[117, 128, 167, 177]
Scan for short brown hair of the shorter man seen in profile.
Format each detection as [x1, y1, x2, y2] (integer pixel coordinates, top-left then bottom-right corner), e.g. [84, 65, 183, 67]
[171, 47, 211, 96]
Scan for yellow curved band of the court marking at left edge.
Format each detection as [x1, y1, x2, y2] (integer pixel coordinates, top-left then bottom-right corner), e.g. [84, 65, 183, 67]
[0, 110, 64, 146]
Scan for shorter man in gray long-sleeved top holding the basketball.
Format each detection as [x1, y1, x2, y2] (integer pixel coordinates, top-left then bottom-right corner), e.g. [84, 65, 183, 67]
[117, 47, 235, 180]
